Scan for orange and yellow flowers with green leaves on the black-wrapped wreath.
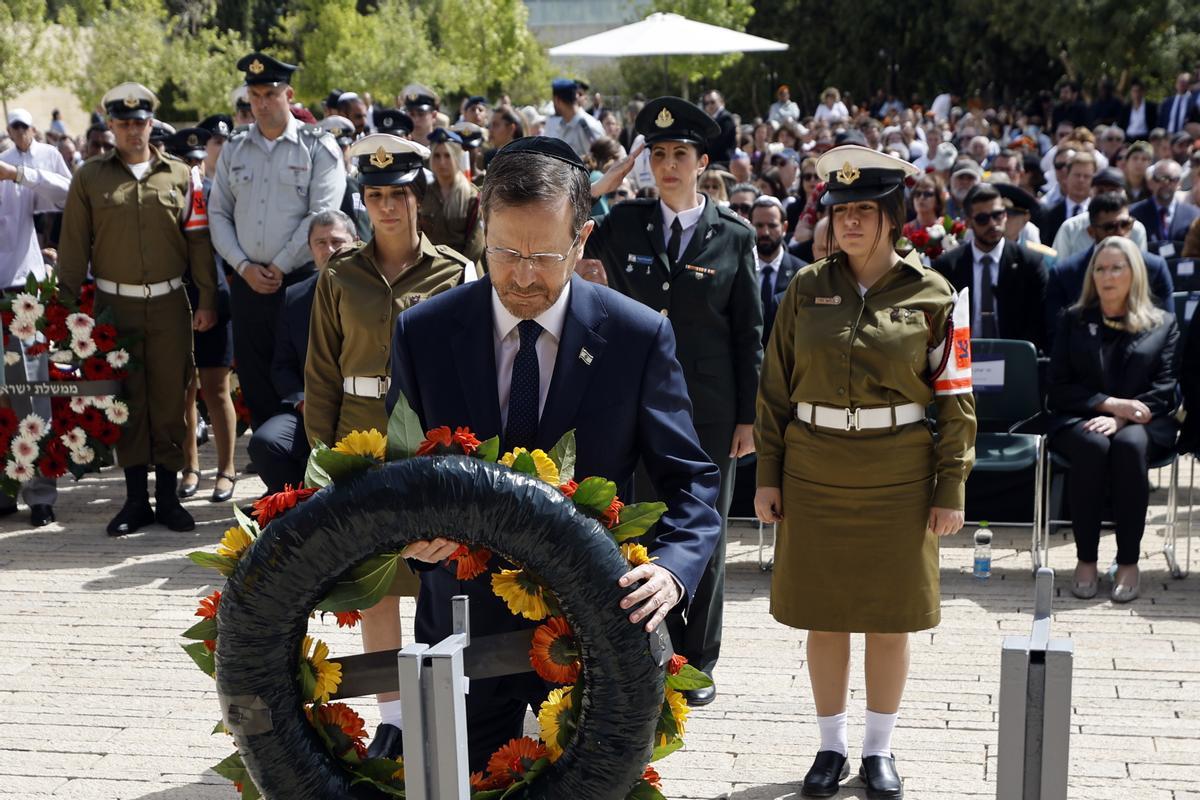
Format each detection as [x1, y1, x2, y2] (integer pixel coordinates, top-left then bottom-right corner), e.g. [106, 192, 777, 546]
[182, 401, 712, 800]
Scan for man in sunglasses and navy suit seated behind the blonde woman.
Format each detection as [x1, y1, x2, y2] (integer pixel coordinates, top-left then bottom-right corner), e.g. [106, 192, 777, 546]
[1045, 192, 1175, 351]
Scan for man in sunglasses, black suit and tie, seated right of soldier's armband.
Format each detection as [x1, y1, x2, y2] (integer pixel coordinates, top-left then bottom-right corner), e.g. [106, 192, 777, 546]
[934, 184, 1046, 350]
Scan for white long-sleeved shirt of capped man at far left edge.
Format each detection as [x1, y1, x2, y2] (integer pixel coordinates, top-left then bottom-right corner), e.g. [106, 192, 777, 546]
[0, 142, 71, 289]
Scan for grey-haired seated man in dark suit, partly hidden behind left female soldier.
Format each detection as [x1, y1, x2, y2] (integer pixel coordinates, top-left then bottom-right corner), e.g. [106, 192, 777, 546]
[247, 209, 356, 494]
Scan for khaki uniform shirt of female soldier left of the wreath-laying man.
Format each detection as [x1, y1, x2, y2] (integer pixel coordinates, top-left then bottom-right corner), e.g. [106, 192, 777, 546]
[304, 235, 469, 446]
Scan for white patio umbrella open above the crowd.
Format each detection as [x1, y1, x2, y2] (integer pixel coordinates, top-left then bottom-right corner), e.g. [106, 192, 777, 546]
[550, 12, 787, 91]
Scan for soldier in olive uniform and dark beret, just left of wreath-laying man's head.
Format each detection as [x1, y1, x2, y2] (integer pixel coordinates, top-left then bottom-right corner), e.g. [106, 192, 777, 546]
[421, 128, 484, 264]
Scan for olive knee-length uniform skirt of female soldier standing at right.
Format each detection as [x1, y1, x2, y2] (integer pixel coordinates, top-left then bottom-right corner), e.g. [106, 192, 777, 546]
[770, 420, 941, 633]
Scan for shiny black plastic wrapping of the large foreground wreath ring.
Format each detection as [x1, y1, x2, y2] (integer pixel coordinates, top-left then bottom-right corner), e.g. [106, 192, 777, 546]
[216, 456, 664, 800]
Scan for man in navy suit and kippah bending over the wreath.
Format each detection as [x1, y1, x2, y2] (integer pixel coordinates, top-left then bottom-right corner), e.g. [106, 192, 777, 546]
[388, 137, 720, 770]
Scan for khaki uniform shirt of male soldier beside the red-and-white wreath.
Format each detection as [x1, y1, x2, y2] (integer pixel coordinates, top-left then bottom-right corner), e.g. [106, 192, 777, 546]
[58, 146, 217, 311]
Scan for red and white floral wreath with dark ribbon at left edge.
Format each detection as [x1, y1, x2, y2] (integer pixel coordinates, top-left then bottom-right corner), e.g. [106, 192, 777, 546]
[0, 275, 133, 497]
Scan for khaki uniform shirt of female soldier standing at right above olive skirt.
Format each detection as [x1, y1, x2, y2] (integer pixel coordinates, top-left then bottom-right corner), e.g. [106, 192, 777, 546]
[755, 252, 976, 509]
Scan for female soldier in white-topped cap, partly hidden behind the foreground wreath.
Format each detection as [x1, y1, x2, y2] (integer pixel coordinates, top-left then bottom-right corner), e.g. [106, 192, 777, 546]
[302, 133, 474, 757]
